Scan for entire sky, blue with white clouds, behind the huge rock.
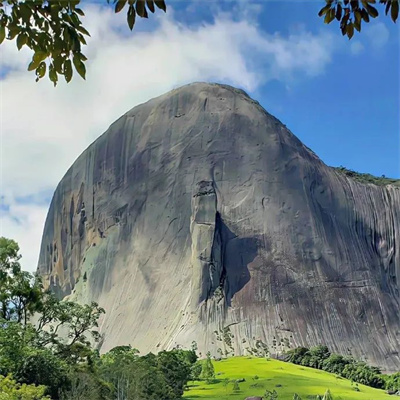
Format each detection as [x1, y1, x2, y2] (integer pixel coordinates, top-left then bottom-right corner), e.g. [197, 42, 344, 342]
[0, 0, 400, 270]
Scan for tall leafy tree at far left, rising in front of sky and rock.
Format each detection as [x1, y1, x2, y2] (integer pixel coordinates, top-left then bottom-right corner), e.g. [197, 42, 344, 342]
[0, 237, 104, 400]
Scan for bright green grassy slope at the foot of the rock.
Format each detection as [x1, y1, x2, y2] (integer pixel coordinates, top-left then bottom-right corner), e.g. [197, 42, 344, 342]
[183, 357, 393, 400]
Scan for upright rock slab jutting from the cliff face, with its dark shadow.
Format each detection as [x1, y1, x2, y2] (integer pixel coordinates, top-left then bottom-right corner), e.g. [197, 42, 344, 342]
[191, 181, 257, 311]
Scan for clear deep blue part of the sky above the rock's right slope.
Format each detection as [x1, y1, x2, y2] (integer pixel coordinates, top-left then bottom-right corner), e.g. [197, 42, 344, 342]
[174, 1, 400, 178]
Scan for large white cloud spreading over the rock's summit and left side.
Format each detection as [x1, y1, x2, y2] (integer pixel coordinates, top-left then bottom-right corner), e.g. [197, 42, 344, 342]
[0, 6, 334, 270]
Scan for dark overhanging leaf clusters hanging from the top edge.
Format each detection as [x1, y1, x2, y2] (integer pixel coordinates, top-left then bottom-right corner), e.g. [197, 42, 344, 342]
[0, 0, 399, 86]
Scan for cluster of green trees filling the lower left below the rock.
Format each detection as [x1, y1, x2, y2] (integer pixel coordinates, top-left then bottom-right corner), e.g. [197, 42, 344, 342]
[0, 237, 197, 400]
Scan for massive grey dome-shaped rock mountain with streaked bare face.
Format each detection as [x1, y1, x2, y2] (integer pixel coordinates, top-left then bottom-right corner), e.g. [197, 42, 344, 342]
[38, 83, 400, 371]
